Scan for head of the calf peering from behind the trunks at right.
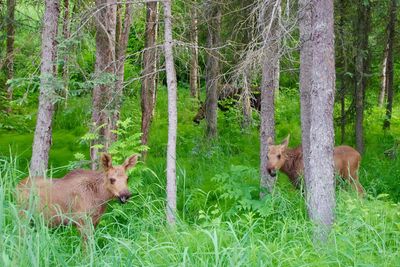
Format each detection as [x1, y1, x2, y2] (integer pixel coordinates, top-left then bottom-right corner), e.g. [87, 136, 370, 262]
[267, 135, 290, 177]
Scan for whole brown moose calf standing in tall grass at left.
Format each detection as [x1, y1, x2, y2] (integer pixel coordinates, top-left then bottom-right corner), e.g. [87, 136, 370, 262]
[17, 154, 137, 238]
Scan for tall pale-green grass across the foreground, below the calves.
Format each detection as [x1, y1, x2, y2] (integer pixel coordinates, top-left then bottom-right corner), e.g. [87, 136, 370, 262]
[0, 156, 400, 266]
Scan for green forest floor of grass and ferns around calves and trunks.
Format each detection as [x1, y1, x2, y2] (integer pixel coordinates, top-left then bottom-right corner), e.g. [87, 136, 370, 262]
[0, 89, 400, 266]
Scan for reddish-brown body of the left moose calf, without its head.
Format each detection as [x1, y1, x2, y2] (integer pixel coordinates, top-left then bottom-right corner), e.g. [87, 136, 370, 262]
[18, 170, 110, 226]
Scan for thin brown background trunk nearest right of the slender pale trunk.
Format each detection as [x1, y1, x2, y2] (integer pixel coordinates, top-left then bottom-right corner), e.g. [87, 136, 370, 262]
[190, 3, 199, 98]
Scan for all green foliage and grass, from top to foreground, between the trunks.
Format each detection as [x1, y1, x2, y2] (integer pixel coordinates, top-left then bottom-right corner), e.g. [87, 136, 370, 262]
[0, 1, 400, 266]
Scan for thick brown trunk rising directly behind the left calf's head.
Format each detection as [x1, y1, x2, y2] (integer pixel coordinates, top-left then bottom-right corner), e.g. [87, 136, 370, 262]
[90, 0, 117, 170]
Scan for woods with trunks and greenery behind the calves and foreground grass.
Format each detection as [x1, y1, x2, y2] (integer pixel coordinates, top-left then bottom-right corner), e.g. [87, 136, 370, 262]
[0, 0, 400, 264]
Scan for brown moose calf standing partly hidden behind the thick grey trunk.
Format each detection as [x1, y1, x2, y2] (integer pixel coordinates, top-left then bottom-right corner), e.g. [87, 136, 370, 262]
[267, 137, 364, 195]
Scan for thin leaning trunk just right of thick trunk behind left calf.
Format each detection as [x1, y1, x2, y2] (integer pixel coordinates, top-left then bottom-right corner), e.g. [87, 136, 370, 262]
[111, 3, 133, 142]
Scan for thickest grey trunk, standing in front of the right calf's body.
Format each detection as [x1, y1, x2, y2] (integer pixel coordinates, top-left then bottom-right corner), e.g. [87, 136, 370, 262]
[300, 0, 335, 241]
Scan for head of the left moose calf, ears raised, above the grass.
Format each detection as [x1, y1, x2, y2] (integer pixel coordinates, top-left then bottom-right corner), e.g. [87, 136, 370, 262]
[101, 153, 138, 203]
